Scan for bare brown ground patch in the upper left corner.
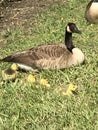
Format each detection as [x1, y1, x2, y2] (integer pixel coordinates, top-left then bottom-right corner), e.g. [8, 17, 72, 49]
[0, 0, 62, 33]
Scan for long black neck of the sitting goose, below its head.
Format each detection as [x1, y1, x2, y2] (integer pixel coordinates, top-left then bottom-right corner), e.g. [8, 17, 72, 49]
[65, 31, 74, 53]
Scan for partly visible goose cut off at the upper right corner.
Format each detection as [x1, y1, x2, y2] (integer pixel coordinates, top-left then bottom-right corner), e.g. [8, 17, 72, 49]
[85, 0, 98, 23]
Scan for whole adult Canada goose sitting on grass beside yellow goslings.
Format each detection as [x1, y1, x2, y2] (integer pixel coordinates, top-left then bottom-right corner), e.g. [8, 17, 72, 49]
[1, 23, 84, 70]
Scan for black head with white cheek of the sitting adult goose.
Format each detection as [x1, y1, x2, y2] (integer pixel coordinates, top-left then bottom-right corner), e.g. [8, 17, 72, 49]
[66, 23, 81, 34]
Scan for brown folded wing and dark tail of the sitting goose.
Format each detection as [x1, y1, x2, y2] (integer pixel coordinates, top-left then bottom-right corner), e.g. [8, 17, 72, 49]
[1, 44, 68, 66]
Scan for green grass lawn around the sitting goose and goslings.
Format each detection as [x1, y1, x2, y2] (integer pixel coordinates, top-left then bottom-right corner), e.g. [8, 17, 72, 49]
[0, 0, 98, 130]
